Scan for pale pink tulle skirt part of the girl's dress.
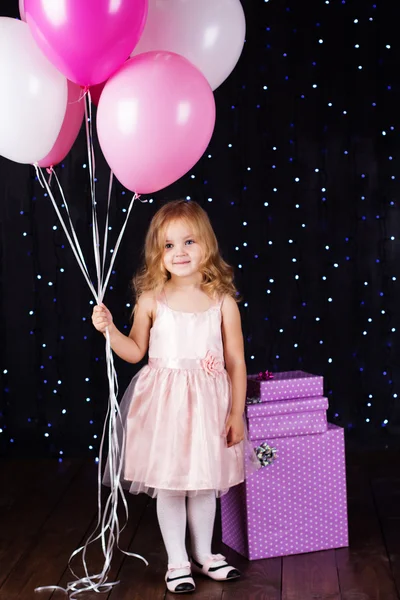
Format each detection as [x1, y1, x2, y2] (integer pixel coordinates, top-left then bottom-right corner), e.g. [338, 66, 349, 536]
[103, 365, 259, 497]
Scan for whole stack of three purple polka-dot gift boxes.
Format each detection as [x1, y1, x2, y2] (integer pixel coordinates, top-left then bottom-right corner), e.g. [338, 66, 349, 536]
[221, 371, 348, 560]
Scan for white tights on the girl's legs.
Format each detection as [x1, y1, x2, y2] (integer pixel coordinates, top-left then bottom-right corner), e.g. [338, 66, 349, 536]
[157, 490, 216, 565]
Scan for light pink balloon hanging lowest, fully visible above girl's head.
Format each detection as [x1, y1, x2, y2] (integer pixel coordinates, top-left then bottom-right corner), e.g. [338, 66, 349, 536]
[97, 52, 215, 194]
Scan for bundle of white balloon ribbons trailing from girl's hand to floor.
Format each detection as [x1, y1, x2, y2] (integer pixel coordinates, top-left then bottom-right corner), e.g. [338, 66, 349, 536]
[35, 120, 148, 600]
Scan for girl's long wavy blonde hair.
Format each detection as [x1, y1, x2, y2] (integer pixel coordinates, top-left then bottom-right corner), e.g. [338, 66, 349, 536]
[132, 200, 237, 301]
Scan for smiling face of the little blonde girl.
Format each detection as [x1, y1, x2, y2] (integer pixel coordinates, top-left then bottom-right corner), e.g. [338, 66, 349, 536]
[163, 220, 204, 277]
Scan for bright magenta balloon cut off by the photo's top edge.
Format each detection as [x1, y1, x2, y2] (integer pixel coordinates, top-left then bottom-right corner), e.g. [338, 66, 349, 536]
[25, 0, 147, 86]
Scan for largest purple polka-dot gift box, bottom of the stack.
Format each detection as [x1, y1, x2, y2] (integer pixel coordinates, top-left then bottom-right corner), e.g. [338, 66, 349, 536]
[221, 424, 348, 560]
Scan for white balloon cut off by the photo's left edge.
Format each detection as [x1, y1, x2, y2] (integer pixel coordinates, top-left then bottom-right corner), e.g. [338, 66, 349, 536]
[0, 17, 67, 163]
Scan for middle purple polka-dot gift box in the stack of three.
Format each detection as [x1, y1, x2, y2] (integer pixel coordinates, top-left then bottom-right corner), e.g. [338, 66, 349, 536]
[246, 398, 328, 440]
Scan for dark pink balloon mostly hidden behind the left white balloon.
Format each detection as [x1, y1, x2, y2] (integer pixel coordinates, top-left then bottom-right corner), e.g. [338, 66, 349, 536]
[38, 81, 85, 167]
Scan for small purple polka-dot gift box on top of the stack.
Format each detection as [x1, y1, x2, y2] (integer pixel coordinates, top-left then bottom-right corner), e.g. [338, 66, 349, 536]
[247, 371, 324, 402]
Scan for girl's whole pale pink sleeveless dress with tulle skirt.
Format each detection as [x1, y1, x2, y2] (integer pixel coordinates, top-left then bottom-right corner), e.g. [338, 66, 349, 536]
[108, 300, 245, 496]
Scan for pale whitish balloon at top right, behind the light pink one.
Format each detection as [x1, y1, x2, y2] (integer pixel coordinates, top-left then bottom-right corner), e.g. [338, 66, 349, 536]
[132, 0, 246, 90]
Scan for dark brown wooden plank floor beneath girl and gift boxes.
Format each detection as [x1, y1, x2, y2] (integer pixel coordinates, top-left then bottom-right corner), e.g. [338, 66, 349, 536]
[0, 440, 400, 600]
